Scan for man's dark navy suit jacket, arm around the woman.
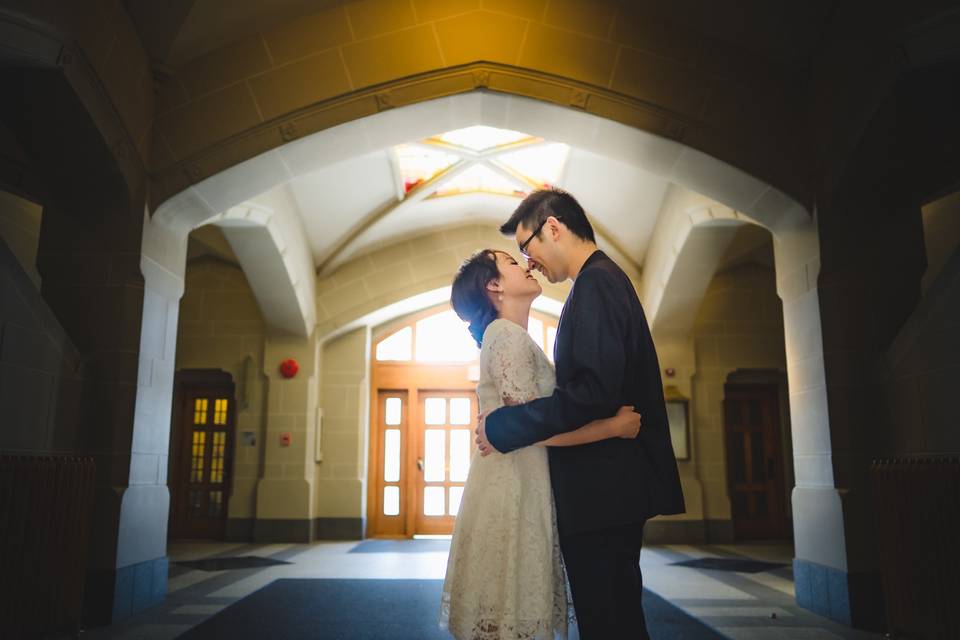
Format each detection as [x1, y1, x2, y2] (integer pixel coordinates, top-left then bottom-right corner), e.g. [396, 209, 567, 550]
[486, 251, 684, 535]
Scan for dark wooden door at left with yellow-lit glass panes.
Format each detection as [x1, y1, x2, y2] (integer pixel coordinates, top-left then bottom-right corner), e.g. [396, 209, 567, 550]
[169, 372, 235, 540]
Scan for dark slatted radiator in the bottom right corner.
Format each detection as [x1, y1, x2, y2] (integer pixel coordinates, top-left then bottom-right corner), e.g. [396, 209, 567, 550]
[872, 457, 960, 640]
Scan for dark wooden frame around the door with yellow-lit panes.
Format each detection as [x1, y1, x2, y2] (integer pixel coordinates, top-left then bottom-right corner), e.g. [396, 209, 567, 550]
[167, 369, 237, 539]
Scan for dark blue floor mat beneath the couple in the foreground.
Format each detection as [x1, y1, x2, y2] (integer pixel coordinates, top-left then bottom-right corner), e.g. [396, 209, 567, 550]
[180, 578, 723, 640]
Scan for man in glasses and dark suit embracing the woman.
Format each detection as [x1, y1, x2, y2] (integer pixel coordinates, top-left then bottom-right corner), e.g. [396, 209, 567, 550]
[477, 189, 684, 640]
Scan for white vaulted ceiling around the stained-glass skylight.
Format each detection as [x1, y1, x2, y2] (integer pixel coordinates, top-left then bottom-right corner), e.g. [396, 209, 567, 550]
[288, 137, 669, 271]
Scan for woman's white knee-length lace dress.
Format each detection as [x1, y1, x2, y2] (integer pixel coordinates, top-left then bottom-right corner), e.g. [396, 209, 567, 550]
[440, 319, 572, 640]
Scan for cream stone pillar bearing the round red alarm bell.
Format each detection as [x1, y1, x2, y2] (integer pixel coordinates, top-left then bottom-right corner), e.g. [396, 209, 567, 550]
[253, 332, 319, 542]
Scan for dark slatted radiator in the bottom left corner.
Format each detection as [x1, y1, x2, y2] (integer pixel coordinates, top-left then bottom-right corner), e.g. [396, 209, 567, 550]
[0, 456, 95, 638]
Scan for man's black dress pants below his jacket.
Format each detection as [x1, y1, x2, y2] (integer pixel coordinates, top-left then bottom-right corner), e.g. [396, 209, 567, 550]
[560, 522, 650, 640]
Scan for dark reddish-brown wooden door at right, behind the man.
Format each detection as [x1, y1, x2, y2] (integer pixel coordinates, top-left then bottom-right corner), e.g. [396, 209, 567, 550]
[724, 384, 790, 540]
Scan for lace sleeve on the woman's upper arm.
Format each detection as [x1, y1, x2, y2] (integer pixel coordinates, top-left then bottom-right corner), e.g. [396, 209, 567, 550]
[487, 321, 539, 404]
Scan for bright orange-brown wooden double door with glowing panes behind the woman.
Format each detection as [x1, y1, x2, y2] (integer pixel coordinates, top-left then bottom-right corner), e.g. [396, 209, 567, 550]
[367, 367, 477, 537]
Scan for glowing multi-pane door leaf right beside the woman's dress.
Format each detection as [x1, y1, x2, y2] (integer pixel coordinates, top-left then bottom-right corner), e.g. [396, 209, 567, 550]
[411, 390, 477, 534]
